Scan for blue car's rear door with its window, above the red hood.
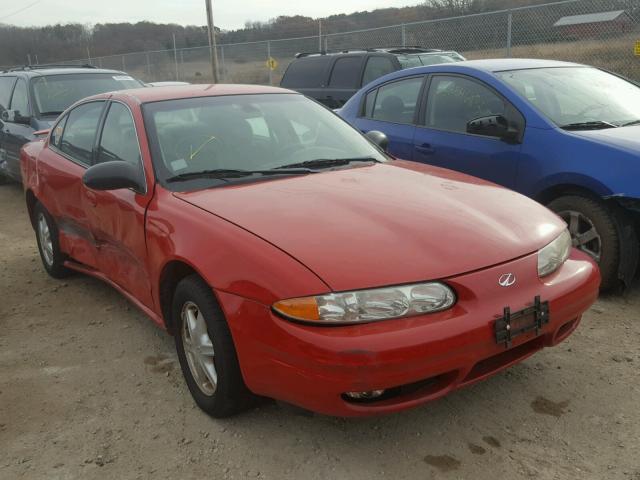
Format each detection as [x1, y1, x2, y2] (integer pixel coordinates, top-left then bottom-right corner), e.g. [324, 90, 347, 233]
[348, 75, 425, 160]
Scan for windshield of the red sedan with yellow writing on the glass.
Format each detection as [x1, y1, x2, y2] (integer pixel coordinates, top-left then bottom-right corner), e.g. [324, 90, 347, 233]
[143, 94, 386, 188]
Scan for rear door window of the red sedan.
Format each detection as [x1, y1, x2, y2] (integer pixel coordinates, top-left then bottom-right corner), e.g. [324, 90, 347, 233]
[60, 102, 104, 165]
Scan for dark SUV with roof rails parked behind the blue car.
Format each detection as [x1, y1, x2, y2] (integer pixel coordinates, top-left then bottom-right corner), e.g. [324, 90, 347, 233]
[280, 47, 465, 108]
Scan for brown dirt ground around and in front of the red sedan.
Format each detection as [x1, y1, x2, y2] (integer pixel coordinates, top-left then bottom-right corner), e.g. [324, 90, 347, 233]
[0, 181, 640, 480]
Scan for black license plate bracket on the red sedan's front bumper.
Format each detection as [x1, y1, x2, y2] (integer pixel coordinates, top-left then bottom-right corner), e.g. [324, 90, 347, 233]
[493, 295, 549, 348]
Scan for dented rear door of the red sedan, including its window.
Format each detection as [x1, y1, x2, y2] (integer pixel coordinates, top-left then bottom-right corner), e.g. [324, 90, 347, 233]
[37, 101, 105, 268]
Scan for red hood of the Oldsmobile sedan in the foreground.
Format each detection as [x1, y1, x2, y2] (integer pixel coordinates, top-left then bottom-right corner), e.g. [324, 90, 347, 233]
[174, 161, 565, 290]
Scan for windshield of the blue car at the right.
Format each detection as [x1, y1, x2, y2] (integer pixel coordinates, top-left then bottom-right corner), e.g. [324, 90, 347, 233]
[496, 67, 640, 129]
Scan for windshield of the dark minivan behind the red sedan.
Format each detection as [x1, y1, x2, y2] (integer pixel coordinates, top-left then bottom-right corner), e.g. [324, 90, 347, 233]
[31, 73, 143, 115]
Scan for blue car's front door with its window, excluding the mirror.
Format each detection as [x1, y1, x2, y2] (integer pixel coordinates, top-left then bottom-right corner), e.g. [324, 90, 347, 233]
[413, 74, 524, 188]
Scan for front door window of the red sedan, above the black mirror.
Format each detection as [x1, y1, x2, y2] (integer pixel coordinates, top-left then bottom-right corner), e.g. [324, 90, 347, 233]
[98, 102, 142, 165]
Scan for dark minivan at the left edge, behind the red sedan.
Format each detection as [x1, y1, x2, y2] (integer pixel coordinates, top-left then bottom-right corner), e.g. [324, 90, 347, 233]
[0, 65, 143, 183]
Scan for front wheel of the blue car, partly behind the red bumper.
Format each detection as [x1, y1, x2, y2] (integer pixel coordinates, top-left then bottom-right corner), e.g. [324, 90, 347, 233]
[547, 195, 620, 291]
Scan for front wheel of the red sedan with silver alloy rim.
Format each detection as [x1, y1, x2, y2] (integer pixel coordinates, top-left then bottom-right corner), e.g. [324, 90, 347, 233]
[172, 275, 254, 418]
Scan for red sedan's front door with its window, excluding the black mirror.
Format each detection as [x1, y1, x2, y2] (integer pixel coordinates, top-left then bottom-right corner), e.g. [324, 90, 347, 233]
[83, 101, 153, 307]
